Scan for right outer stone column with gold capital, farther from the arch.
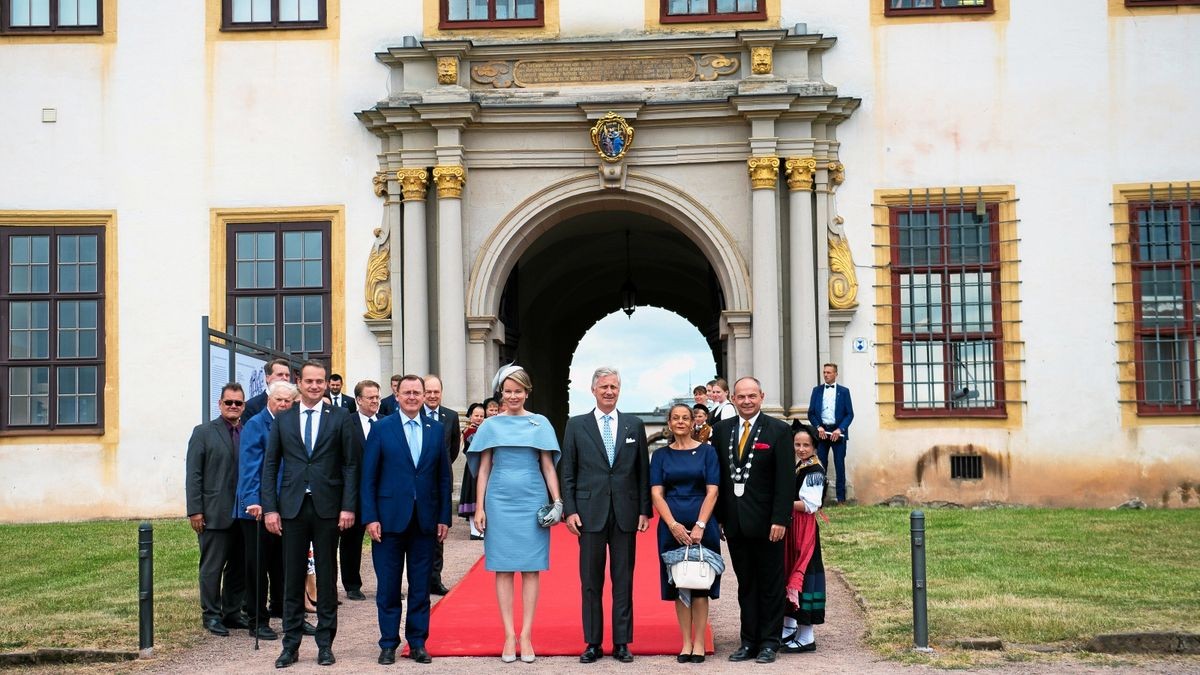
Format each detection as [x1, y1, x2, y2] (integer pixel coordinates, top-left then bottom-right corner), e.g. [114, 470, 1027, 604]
[785, 157, 821, 414]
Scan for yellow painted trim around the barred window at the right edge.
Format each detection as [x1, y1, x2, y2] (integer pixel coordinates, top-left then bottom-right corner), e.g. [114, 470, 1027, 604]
[1112, 180, 1200, 429]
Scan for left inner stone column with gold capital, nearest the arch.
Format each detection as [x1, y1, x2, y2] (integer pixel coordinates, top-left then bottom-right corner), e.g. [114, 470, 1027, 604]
[433, 165, 467, 411]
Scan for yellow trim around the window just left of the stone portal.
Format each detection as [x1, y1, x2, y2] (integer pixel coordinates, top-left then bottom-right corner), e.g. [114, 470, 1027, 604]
[209, 204, 347, 372]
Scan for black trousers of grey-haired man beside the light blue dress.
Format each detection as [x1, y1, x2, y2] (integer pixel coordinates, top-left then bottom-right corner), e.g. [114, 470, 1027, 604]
[580, 512, 638, 645]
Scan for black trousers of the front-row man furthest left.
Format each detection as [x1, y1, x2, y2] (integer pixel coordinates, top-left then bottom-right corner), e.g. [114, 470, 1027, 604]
[283, 496, 340, 650]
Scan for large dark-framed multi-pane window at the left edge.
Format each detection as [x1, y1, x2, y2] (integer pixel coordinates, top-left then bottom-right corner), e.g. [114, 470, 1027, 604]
[0, 226, 106, 434]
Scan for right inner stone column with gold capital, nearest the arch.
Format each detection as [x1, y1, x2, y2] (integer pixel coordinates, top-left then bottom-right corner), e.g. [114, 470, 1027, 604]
[738, 156, 784, 414]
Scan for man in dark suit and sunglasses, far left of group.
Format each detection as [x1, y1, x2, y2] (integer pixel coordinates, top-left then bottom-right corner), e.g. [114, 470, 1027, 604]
[185, 382, 248, 637]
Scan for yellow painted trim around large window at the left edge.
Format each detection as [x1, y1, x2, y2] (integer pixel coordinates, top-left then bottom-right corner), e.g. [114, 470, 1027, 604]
[0, 210, 121, 444]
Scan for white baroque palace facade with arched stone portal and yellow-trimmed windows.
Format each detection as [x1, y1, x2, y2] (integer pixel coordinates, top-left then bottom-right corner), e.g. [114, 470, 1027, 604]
[0, 0, 1200, 521]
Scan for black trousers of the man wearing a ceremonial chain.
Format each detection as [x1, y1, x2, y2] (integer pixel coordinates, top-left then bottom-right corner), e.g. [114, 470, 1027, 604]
[727, 537, 786, 650]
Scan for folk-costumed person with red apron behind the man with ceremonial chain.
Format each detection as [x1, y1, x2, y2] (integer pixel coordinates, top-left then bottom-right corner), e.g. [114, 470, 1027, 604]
[780, 426, 826, 653]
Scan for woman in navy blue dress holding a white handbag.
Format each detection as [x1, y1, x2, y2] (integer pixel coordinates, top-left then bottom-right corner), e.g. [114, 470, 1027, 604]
[650, 404, 721, 663]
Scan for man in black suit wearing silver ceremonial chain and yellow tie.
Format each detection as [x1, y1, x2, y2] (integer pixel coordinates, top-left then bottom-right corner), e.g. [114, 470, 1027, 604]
[712, 377, 796, 663]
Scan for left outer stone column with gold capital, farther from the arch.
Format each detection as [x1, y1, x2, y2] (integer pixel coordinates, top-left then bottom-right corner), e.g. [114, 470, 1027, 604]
[391, 168, 430, 375]
